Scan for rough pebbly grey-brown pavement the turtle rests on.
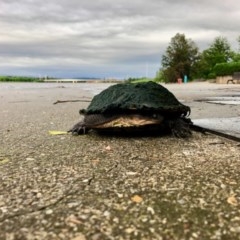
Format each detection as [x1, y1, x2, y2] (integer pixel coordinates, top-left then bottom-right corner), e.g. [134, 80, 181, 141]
[0, 83, 240, 240]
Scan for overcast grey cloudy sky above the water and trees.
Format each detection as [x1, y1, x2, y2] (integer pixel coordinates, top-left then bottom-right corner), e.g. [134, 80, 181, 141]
[0, 0, 240, 78]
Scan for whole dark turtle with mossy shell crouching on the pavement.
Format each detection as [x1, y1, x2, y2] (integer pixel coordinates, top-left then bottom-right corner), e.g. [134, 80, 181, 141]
[68, 81, 192, 138]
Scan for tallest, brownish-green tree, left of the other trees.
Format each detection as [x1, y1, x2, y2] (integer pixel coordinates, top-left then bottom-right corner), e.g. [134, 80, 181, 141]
[162, 33, 199, 82]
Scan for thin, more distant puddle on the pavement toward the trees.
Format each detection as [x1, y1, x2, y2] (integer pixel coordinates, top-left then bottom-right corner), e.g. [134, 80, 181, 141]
[195, 95, 240, 105]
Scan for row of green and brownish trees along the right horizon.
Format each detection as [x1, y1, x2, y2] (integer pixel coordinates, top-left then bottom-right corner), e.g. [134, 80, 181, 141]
[156, 33, 240, 82]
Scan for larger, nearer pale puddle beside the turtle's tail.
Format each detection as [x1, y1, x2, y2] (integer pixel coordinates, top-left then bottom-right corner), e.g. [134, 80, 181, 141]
[192, 117, 240, 138]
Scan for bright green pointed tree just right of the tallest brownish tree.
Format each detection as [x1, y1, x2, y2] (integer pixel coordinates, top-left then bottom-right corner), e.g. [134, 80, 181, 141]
[197, 37, 234, 78]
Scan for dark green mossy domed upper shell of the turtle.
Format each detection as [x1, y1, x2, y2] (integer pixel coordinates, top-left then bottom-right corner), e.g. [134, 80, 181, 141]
[80, 81, 190, 117]
